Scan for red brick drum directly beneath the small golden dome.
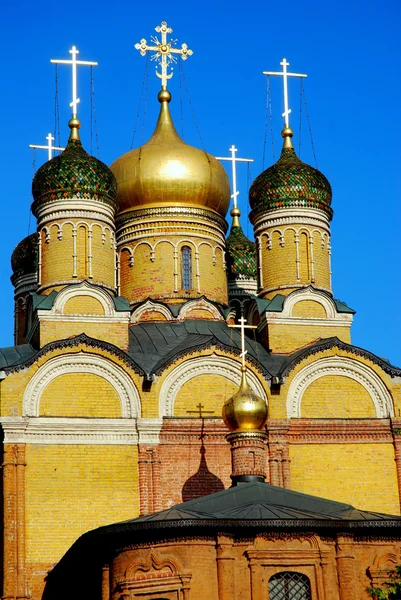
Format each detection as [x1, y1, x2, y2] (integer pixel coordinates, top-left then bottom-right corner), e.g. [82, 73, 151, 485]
[227, 430, 267, 485]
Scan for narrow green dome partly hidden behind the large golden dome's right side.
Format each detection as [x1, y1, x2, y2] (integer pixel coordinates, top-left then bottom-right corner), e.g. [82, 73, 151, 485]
[226, 208, 257, 280]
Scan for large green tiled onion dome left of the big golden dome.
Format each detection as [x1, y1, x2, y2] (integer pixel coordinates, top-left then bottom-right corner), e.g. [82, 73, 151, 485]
[32, 119, 117, 216]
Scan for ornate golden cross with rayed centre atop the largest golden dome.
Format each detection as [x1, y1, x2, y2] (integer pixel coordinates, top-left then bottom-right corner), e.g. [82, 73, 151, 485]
[135, 21, 193, 90]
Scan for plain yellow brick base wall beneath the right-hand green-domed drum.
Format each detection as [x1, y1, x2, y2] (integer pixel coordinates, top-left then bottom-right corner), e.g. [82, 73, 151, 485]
[268, 323, 351, 352]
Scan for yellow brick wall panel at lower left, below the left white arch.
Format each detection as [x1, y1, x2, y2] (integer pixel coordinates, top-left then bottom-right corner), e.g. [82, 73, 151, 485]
[26, 445, 139, 563]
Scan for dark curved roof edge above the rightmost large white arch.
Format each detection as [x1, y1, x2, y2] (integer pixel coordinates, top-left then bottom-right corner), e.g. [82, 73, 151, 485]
[279, 337, 401, 377]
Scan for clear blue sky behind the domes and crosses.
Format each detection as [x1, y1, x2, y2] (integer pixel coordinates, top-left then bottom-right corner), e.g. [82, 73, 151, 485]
[0, 0, 401, 365]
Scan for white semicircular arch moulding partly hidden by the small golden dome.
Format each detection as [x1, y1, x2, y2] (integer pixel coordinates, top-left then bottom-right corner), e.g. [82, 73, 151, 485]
[159, 354, 267, 418]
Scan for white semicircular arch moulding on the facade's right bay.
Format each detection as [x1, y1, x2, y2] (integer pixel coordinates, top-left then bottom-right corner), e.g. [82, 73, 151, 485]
[287, 356, 394, 419]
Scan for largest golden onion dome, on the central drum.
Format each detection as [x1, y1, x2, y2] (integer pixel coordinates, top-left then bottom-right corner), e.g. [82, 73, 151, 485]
[110, 90, 230, 216]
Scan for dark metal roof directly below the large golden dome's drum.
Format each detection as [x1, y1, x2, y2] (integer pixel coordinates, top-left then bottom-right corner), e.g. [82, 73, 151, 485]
[128, 320, 283, 377]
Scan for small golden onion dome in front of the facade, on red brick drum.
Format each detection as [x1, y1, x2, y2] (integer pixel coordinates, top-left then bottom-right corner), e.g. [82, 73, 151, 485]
[223, 367, 267, 431]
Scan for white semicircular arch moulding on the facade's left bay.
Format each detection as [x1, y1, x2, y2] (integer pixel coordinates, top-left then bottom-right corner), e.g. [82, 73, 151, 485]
[22, 352, 141, 419]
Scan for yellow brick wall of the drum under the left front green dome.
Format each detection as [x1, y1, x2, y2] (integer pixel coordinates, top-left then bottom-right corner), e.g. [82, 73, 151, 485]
[41, 219, 116, 291]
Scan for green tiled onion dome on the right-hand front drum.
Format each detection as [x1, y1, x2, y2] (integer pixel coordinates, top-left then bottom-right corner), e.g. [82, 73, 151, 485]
[249, 128, 333, 220]
